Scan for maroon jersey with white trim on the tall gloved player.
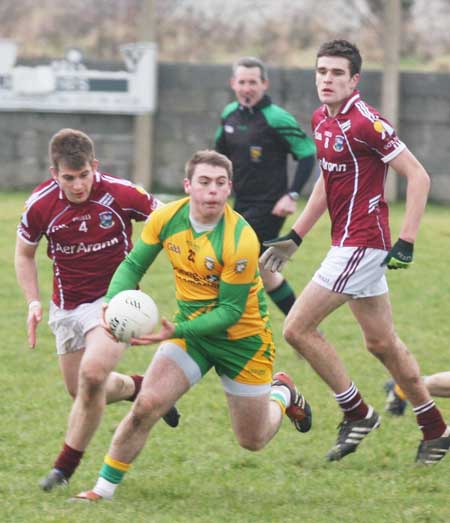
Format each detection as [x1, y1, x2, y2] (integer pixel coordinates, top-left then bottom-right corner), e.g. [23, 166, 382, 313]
[312, 91, 406, 250]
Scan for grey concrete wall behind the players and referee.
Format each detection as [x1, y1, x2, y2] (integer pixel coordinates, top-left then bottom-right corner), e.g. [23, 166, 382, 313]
[0, 63, 450, 203]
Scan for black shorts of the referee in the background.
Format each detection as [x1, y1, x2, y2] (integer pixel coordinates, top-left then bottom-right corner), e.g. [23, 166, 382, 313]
[234, 200, 286, 252]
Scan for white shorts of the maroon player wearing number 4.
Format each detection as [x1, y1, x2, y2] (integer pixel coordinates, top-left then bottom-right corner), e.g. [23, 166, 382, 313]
[48, 298, 104, 355]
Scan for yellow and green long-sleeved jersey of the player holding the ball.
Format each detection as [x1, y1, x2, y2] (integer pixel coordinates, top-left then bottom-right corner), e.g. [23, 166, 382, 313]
[106, 198, 270, 340]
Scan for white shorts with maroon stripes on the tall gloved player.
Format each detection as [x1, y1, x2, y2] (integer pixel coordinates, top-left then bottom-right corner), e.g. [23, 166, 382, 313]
[312, 247, 389, 298]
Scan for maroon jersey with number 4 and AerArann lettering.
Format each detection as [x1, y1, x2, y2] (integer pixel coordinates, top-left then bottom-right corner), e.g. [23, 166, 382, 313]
[18, 172, 159, 309]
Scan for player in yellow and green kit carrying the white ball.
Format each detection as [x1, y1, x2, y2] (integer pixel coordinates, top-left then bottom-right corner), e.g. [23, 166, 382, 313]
[75, 150, 312, 500]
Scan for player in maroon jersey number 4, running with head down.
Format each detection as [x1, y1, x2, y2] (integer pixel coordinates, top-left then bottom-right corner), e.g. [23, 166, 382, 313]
[15, 129, 178, 491]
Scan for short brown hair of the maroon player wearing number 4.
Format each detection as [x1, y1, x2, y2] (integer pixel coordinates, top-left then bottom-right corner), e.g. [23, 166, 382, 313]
[48, 129, 95, 170]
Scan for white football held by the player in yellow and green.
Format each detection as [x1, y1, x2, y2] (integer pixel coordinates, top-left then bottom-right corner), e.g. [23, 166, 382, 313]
[105, 290, 159, 342]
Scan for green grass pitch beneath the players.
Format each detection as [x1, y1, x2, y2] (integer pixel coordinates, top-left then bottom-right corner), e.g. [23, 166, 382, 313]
[0, 193, 450, 523]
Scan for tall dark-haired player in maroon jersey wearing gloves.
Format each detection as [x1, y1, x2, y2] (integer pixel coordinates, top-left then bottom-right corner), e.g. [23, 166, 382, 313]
[261, 40, 450, 464]
